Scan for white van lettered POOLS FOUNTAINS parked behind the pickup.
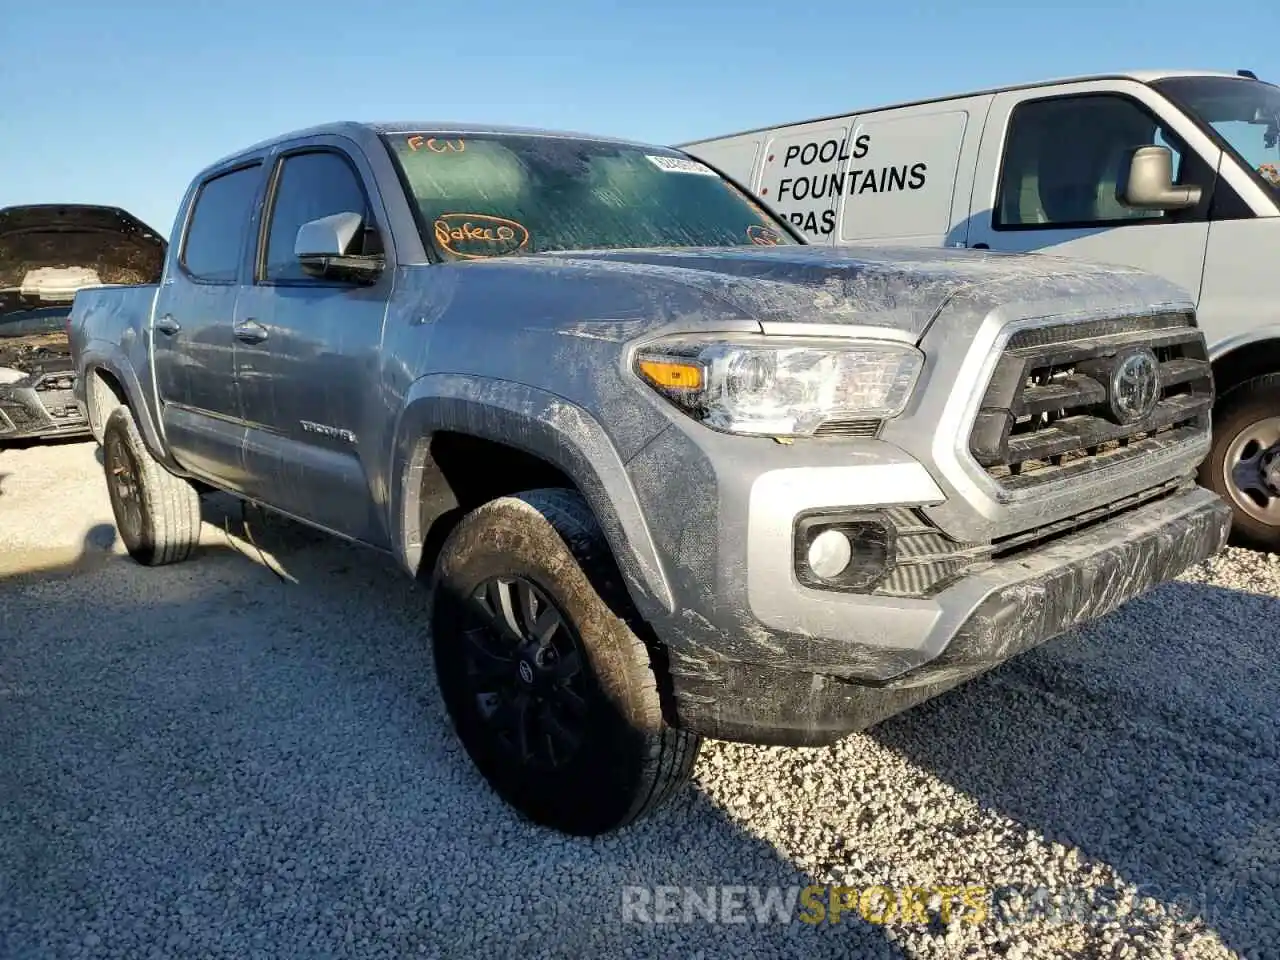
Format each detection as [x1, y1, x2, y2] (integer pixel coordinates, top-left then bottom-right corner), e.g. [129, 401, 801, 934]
[681, 70, 1280, 549]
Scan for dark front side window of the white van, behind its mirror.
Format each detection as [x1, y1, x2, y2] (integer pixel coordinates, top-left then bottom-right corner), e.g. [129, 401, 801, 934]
[993, 95, 1185, 228]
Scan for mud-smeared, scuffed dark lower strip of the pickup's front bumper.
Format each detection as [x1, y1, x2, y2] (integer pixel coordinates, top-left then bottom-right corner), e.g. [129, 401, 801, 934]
[671, 488, 1230, 746]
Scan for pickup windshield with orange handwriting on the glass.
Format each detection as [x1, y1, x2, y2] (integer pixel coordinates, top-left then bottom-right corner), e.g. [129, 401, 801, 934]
[385, 132, 796, 260]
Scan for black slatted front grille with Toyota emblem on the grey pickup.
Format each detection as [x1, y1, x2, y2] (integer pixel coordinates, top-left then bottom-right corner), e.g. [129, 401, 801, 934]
[969, 312, 1213, 490]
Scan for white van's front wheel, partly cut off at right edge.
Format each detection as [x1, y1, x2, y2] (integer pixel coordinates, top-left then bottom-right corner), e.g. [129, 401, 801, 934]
[1199, 374, 1280, 550]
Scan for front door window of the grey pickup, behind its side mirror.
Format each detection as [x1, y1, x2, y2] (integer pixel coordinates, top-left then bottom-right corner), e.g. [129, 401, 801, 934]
[262, 151, 380, 282]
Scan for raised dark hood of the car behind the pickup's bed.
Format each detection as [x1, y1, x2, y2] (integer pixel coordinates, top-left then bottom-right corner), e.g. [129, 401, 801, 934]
[0, 204, 168, 321]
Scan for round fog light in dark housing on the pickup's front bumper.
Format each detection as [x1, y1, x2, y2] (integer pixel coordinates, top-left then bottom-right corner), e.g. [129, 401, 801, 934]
[794, 511, 897, 593]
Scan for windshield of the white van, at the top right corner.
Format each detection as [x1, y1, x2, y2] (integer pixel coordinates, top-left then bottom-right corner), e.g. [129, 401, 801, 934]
[1155, 77, 1280, 198]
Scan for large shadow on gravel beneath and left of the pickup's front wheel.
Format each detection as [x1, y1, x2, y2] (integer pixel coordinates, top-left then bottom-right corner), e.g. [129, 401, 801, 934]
[0, 506, 904, 957]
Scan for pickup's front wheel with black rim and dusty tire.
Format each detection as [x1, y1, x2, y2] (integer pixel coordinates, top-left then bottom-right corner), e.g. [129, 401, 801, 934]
[431, 489, 700, 836]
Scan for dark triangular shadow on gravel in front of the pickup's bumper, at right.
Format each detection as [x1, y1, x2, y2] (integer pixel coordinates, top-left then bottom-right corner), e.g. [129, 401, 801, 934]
[869, 581, 1280, 956]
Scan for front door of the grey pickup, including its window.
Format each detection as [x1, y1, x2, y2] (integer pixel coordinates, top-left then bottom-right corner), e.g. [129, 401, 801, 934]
[233, 138, 394, 545]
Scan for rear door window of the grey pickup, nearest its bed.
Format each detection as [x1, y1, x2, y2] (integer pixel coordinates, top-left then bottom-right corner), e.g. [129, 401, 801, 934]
[182, 164, 261, 283]
